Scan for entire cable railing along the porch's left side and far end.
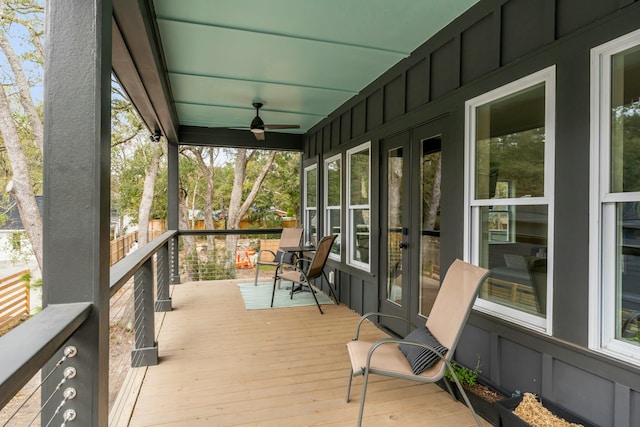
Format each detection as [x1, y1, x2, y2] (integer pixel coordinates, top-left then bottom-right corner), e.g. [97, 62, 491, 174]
[0, 229, 282, 426]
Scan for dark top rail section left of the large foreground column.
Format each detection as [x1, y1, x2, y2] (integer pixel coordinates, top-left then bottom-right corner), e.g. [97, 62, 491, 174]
[0, 302, 91, 408]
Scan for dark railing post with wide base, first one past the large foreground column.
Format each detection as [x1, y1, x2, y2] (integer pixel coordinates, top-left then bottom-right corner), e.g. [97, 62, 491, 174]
[131, 258, 158, 368]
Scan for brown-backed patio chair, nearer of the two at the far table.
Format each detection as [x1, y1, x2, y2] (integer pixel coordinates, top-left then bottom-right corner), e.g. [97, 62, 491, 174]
[271, 234, 338, 314]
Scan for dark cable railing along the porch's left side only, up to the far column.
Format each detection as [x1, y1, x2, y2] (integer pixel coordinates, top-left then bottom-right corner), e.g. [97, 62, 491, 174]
[0, 231, 177, 426]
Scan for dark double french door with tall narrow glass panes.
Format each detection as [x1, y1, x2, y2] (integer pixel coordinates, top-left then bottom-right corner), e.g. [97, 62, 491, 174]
[379, 122, 443, 335]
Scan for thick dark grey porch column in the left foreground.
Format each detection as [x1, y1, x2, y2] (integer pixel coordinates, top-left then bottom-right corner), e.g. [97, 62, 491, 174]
[41, 0, 111, 426]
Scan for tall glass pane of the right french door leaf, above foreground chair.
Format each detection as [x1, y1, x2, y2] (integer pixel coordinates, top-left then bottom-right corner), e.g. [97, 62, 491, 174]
[420, 136, 442, 316]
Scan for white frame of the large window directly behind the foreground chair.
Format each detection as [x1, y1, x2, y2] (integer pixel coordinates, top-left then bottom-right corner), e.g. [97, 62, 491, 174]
[464, 66, 556, 335]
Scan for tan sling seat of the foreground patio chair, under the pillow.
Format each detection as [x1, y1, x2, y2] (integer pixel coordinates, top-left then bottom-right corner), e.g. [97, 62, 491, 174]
[347, 340, 442, 379]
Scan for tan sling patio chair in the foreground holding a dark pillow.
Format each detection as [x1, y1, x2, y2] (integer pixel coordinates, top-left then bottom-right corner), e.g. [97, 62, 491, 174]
[347, 259, 489, 426]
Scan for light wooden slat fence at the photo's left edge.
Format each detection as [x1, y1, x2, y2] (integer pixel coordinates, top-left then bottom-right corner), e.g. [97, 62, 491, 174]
[0, 270, 31, 330]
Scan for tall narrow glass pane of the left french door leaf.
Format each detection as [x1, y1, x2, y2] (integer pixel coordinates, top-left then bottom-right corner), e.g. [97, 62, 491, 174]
[387, 148, 403, 305]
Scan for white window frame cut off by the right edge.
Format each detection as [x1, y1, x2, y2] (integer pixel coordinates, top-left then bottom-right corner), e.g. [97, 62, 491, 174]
[589, 30, 640, 365]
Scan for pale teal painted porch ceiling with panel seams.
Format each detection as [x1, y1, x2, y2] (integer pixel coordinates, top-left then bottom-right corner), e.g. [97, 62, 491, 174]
[153, 0, 478, 133]
